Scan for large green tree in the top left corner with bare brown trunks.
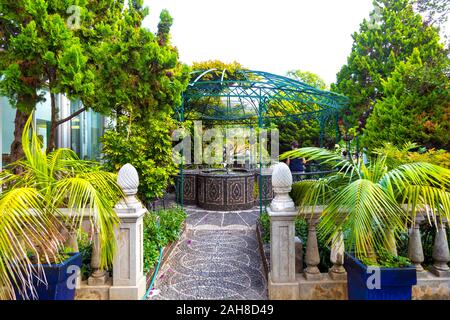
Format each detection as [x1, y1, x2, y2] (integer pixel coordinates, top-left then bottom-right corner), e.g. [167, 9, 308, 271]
[0, 0, 121, 154]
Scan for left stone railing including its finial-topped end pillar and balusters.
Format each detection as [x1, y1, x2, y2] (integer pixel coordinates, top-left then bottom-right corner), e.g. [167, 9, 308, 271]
[62, 164, 147, 300]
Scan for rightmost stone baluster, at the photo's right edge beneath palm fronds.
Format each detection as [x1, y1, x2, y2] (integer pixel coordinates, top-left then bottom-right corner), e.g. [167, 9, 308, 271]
[430, 221, 450, 277]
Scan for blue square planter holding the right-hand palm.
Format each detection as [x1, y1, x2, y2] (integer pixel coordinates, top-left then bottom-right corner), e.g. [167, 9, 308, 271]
[344, 253, 417, 300]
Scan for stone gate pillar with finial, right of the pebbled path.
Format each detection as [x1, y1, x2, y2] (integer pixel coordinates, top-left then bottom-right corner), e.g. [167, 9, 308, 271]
[267, 163, 299, 300]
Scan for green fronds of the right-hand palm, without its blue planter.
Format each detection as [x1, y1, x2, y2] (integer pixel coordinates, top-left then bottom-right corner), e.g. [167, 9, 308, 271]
[281, 148, 450, 261]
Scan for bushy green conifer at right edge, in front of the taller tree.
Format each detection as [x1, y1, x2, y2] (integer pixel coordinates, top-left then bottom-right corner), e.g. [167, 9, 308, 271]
[364, 48, 450, 149]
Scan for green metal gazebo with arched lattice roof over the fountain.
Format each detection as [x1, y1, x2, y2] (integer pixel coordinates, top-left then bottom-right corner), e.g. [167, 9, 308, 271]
[176, 69, 348, 211]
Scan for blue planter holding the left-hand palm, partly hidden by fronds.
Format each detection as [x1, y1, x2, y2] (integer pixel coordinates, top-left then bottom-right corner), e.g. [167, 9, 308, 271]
[16, 252, 81, 300]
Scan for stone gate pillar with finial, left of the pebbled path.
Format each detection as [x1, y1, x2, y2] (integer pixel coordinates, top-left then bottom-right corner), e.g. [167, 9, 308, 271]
[109, 164, 147, 300]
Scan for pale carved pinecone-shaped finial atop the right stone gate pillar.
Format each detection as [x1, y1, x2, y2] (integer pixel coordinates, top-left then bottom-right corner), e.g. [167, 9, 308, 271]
[271, 162, 295, 211]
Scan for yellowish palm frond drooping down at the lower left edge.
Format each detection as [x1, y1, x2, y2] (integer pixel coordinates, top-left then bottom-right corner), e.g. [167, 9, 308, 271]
[0, 188, 62, 299]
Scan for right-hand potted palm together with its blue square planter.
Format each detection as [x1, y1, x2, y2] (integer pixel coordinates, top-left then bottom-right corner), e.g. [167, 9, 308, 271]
[281, 148, 450, 300]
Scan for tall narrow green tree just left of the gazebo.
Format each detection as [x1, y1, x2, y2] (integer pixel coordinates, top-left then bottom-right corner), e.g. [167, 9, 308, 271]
[97, 7, 188, 201]
